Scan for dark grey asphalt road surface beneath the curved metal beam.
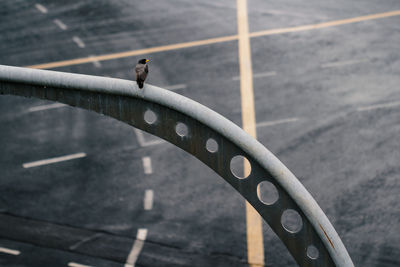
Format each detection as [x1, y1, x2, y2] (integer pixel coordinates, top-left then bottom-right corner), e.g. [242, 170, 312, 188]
[0, 0, 400, 266]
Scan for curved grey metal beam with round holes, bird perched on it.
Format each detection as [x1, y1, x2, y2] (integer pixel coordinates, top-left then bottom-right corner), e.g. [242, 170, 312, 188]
[0, 65, 354, 267]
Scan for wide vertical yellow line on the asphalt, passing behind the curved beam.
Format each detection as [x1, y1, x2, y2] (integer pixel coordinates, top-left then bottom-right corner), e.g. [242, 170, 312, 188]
[237, 0, 264, 267]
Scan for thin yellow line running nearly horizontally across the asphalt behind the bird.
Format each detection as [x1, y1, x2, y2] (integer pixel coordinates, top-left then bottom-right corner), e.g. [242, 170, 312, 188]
[27, 10, 400, 69]
